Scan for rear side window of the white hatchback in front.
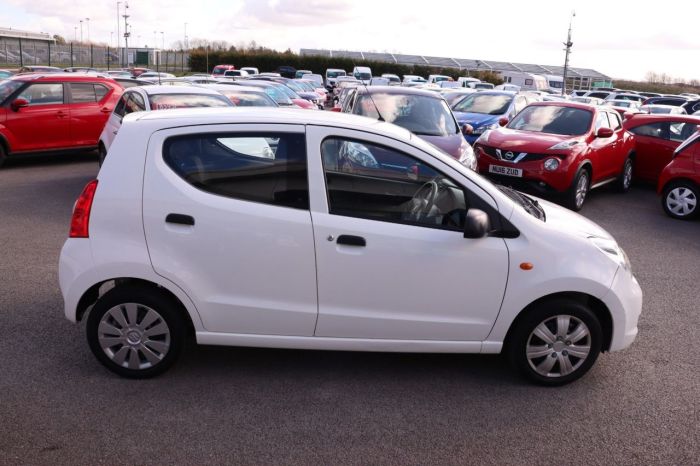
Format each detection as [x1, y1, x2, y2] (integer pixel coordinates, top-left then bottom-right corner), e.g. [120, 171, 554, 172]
[163, 133, 309, 209]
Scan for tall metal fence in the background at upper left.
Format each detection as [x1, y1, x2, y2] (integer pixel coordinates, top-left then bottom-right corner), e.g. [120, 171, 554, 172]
[0, 38, 189, 73]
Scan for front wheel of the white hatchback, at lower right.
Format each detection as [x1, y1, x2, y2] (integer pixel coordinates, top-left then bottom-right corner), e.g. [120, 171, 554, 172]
[506, 299, 603, 386]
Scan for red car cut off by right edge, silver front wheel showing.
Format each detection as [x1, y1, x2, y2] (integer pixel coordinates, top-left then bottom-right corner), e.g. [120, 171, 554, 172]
[657, 126, 700, 220]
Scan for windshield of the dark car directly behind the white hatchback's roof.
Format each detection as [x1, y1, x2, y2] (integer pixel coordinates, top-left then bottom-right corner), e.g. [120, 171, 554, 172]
[353, 93, 458, 136]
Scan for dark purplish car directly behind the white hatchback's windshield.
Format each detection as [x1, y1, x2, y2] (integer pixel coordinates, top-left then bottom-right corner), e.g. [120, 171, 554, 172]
[341, 86, 476, 170]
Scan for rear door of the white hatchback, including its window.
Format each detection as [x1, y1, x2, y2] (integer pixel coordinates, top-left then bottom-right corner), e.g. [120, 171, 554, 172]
[143, 125, 318, 336]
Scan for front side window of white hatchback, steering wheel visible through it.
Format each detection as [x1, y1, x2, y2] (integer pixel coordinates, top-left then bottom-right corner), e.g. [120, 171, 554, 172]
[321, 138, 468, 231]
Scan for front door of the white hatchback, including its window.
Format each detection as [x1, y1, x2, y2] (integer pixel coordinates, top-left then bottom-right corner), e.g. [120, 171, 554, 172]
[307, 126, 508, 341]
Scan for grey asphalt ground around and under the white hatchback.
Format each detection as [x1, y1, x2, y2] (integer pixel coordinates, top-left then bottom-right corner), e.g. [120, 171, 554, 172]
[0, 156, 700, 465]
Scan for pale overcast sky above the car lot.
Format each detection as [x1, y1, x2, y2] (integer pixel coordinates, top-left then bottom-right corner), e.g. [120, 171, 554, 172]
[5, 0, 700, 80]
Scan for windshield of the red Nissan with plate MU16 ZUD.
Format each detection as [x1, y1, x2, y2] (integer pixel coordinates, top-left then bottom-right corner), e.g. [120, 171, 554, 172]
[508, 105, 593, 136]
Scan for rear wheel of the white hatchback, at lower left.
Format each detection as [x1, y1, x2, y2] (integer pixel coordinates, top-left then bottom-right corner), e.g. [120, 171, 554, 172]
[86, 286, 185, 379]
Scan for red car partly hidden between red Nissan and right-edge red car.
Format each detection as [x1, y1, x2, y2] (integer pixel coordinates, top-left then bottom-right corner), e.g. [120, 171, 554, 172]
[622, 114, 700, 184]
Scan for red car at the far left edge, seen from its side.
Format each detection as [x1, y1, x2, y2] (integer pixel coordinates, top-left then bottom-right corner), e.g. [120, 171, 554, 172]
[0, 73, 123, 164]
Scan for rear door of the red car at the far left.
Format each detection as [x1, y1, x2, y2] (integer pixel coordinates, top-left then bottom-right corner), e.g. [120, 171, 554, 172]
[67, 82, 114, 146]
